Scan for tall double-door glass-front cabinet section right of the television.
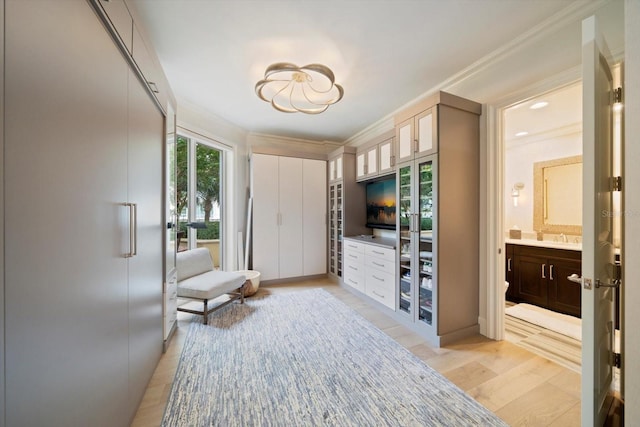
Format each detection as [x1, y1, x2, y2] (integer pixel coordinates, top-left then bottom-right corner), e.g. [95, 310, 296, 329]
[396, 156, 437, 332]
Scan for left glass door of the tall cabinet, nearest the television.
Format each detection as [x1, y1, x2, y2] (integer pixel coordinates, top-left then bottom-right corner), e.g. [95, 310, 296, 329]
[397, 165, 414, 313]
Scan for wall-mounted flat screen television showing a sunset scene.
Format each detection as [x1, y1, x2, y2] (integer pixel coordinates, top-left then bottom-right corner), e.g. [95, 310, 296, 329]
[367, 175, 396, 230]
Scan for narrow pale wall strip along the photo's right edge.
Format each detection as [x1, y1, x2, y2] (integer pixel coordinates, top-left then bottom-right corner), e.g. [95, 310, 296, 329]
[622, 0, 640, 425]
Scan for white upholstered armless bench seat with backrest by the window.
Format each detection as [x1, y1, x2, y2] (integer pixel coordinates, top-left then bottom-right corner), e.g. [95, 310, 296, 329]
[176, 248, 246, 325]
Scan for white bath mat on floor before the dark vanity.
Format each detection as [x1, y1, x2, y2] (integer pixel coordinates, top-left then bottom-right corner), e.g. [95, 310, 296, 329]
[505, 304, 582, 341]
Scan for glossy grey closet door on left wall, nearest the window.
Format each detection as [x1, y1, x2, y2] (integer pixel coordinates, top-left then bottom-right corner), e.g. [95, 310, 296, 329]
[128, 72, 164, 411]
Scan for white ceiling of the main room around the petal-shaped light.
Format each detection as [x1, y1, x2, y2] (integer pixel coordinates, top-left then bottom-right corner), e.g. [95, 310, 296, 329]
[128, 0, 573, 142]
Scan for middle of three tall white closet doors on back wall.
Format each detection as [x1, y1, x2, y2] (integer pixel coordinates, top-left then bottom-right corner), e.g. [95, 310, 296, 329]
[278, 157, 304, 279]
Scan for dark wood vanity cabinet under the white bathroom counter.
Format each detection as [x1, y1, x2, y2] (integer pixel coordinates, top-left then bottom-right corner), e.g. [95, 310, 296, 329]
[506, 244, 582, 317]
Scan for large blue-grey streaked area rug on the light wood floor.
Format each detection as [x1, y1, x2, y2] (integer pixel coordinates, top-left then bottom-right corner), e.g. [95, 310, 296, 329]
[162, 289, 506, 427]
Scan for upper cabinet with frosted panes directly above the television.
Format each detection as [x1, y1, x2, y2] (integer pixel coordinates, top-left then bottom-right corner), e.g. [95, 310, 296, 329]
[356, 130, 395, 181]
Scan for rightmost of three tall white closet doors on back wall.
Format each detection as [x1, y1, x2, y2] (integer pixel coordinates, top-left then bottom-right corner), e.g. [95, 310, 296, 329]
[302, 159, 327, 276]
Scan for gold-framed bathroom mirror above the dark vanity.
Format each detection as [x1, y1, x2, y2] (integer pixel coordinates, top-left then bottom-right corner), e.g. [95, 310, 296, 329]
[533, 156, 582, 235]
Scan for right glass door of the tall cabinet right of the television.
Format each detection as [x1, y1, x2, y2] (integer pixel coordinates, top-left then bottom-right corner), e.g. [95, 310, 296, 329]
[416, 161, 434, 325]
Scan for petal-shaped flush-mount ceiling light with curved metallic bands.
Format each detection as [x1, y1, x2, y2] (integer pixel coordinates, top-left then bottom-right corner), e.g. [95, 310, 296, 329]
[255, 62, 344, 114]
